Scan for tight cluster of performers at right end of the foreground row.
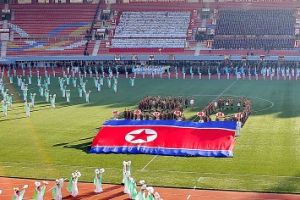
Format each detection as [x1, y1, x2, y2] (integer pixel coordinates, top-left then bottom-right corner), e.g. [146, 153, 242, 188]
[122, 161, 163, 200]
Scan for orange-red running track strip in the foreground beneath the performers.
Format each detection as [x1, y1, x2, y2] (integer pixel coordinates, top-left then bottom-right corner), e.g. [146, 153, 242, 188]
[0, 177, 300, 200]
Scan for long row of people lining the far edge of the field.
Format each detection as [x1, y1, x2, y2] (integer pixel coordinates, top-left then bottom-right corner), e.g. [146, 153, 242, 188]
[2, 58, 300, 80]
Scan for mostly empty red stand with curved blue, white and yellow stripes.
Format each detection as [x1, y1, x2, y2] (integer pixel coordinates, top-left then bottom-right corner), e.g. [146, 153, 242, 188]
[2, 4, 97, 56]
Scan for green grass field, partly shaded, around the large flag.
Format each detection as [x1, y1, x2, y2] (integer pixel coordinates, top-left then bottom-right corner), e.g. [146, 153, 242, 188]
[0, 75, 300, 193]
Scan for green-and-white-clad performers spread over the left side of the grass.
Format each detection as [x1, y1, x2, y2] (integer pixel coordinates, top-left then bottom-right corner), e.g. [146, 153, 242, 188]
[0, 65, 135, 117]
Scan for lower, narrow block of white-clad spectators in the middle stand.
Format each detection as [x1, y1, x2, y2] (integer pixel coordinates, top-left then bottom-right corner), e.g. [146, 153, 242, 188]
[110, 38, 186, 48]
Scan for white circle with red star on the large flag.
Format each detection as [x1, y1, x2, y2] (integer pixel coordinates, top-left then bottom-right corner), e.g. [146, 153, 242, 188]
[125, 129, 157, 144]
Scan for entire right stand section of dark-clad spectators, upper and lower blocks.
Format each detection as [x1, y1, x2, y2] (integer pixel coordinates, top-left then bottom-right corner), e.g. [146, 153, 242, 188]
[212, 9, 295, 51]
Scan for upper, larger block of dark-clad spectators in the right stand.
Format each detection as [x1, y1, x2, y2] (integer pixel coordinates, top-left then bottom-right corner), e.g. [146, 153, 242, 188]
[216, 9, 295, 35]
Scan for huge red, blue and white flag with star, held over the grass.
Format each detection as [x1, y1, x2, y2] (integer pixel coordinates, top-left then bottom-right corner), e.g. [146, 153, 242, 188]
[90, 120, 236, 157]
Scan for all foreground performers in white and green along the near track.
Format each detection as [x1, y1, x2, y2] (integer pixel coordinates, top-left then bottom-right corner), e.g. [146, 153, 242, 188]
[0, 161, 163, 200]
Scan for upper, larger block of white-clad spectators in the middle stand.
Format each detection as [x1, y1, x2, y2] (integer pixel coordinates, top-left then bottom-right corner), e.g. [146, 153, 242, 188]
[115, 11, 191, 38]
